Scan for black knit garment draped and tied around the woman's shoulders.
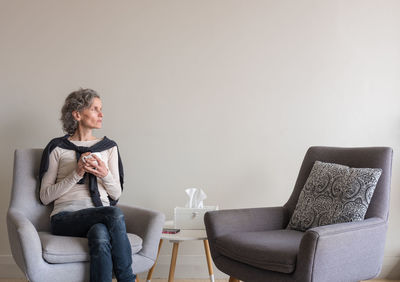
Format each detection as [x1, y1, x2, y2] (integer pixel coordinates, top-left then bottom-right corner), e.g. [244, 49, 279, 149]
[39, 134, 124, 207]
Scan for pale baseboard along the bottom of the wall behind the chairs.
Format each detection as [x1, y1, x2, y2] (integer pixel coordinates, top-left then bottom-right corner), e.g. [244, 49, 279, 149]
[0, 254, 400, 280]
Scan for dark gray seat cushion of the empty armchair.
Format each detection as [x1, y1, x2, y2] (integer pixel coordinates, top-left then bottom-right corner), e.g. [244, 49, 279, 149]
[215, 230, 304, 273]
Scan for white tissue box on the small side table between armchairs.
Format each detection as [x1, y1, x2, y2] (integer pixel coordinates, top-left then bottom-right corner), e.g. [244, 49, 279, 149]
[174, 206, 218, 229]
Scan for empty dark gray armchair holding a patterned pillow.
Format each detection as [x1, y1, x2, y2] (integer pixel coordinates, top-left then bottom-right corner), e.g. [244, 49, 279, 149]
[204, 147, 392, 282]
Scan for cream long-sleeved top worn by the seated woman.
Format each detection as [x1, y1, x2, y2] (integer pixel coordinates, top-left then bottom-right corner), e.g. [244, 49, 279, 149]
[40, 139, 122, 216]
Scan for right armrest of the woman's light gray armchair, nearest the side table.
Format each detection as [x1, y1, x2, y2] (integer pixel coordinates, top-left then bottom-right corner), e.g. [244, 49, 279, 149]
[118, 205, 165, 260]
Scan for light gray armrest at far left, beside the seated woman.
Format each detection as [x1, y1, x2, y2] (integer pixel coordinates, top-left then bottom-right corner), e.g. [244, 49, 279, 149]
[7, 208, 43, 274]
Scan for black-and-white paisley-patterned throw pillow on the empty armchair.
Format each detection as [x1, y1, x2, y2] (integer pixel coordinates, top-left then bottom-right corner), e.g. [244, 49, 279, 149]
[288, 161, 382, 231]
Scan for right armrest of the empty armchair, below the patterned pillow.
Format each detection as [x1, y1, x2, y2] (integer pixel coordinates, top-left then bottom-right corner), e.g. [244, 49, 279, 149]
[298, 217, 387, 281]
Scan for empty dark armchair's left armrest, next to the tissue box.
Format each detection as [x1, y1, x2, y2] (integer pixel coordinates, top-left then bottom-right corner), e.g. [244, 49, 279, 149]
[204, 207, 289, 241]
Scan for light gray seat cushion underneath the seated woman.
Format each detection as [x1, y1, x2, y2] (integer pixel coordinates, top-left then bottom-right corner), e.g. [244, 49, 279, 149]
[39, 232, 142, 263]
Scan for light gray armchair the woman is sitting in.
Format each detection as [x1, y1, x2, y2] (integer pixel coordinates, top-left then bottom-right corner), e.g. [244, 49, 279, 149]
[7, 149, 164, 282]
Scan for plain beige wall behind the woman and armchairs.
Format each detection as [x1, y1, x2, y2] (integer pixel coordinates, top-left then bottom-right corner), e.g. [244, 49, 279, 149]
[0, 0, 400, 278]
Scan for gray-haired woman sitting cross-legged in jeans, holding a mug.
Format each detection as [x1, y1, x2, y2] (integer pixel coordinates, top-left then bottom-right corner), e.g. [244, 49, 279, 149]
[40, 89, 136, 282]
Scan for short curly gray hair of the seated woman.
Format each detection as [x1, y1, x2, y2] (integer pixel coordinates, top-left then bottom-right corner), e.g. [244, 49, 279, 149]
[60, 88, 100, 135]
